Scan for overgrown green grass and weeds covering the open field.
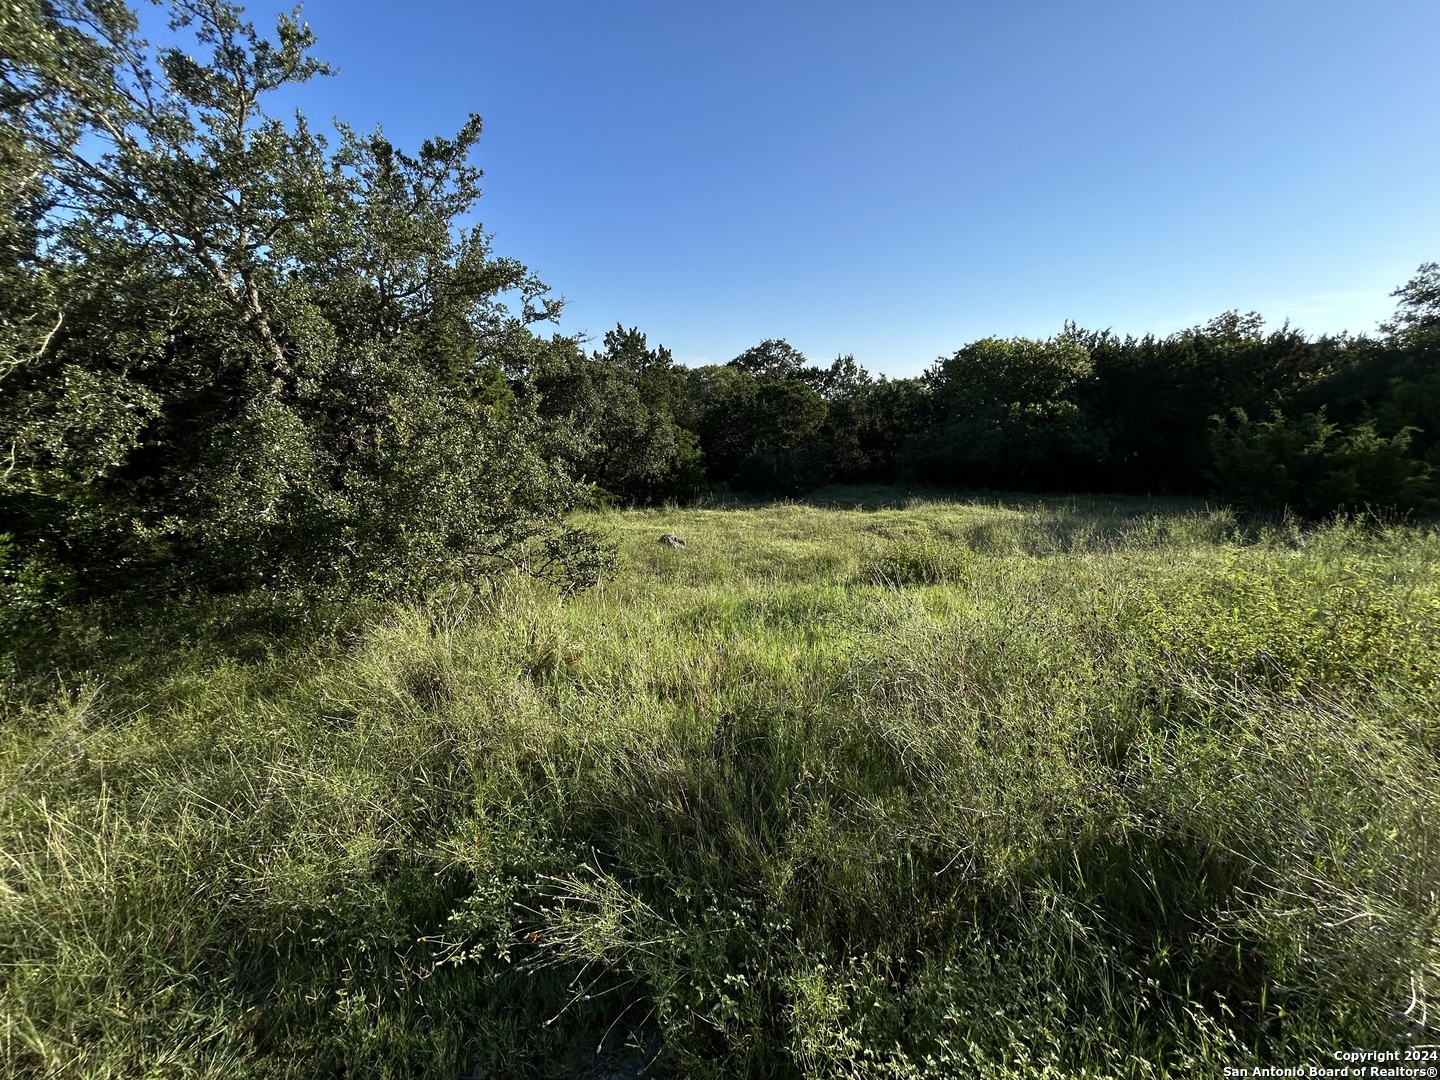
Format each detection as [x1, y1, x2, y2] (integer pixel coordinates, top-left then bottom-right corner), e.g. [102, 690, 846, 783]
[0, 490, 1440, 1080]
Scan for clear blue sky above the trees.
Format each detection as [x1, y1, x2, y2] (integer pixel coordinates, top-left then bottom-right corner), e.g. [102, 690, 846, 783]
[227, 0, 1440, 376]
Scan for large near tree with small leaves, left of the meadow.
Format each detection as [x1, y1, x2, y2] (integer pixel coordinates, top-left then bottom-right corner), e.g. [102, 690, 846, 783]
[0, 0, 603, 601]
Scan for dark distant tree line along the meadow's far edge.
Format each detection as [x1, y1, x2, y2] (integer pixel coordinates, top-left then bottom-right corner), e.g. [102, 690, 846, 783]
[529, 280, 1440, 517]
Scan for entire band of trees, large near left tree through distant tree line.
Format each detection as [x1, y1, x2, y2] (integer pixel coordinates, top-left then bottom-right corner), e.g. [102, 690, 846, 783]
[0, 0, 1440, 609]
